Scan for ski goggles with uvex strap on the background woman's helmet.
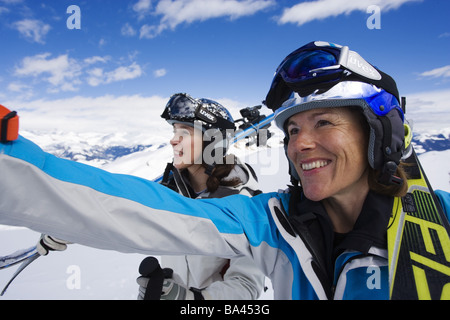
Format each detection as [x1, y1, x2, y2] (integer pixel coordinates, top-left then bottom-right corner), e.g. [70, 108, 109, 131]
[161, 93, 235, 129]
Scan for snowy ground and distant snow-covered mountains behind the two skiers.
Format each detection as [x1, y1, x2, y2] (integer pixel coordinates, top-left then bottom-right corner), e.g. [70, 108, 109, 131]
[0, 128, 450, 300]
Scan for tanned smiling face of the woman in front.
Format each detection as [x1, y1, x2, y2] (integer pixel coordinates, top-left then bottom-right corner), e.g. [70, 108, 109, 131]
[287, 108, 369, 201]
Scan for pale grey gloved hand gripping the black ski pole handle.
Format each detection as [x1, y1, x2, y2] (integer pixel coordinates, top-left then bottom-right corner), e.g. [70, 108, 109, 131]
[136, 268, 199, 300]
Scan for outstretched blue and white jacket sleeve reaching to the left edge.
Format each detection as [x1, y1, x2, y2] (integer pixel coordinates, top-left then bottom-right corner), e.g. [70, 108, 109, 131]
[0, 137, 276, 258]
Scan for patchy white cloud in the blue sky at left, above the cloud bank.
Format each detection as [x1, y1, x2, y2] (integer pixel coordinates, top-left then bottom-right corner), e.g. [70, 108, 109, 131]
[14, 53, 143, 93]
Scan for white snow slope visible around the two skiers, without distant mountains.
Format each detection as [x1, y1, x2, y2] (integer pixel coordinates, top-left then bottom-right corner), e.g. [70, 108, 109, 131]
[0, 129, 450, 300]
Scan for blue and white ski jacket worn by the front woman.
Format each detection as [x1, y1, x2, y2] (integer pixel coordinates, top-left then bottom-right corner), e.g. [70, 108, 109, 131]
[0, 137, 449, 299]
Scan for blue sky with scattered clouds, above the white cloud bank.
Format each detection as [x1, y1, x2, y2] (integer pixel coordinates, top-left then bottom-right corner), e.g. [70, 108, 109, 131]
[0, 0, 450, 132]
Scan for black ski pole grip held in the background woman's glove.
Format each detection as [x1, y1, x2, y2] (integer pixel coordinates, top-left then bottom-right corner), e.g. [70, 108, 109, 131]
[139, 257, 164, 300]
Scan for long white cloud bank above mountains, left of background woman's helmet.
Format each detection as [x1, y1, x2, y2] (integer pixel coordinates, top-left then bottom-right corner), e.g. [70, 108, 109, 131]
[7, 95, 171, 136]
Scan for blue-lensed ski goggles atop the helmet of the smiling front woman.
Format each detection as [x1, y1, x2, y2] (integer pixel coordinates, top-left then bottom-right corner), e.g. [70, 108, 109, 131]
[265, 41, 399, 111]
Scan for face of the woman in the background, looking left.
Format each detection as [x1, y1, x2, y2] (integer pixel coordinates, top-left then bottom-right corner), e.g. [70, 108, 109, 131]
[170, 123, 203, 170]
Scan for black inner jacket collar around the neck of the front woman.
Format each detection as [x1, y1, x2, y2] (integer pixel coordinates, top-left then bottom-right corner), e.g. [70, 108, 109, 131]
[288, 188, 393, 295]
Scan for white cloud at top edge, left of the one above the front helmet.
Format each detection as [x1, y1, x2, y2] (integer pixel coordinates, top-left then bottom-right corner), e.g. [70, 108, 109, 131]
[140, 0, 276, 38]
